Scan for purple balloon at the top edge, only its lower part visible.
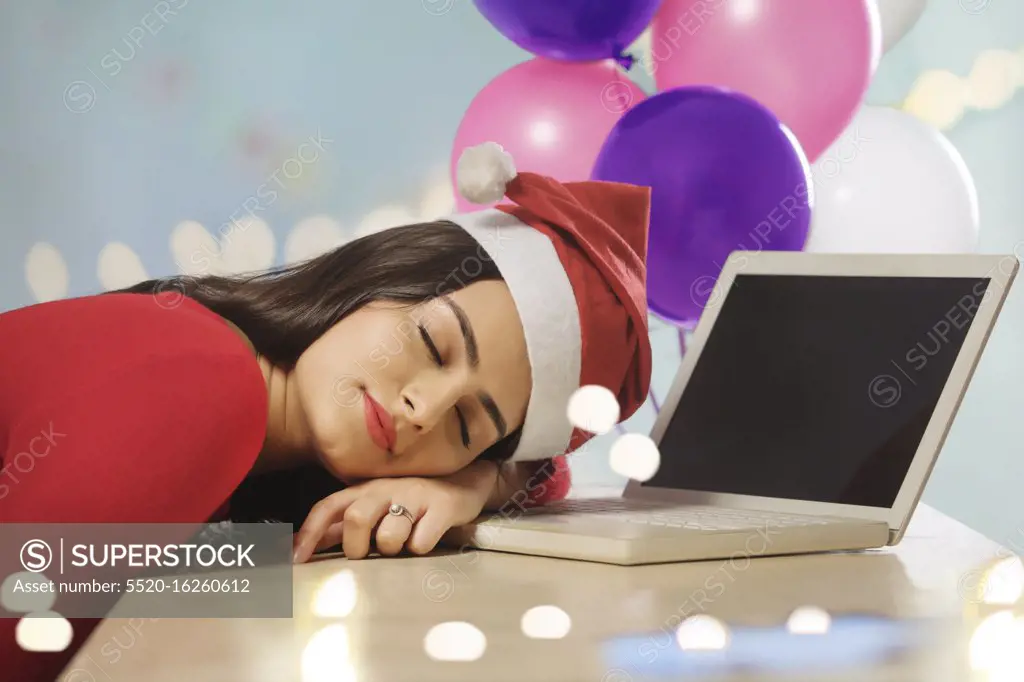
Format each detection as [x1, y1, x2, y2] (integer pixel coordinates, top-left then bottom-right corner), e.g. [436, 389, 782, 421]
[474, 0, 662, 61]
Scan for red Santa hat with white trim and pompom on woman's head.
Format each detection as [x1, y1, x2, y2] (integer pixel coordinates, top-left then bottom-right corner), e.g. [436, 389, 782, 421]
[451, 142, 651, 461]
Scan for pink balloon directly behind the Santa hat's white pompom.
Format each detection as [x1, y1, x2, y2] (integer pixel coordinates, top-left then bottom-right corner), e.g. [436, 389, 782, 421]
[452, 57, 646, 211]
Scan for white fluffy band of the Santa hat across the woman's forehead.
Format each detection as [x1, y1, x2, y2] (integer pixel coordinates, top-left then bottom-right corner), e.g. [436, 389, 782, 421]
[451, 209, 582, 462]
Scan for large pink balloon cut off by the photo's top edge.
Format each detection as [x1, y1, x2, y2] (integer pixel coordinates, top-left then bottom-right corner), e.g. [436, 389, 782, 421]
[649, 0, 881, 161]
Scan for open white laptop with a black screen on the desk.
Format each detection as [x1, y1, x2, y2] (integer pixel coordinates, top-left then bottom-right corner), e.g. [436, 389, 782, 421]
[445, 251, 1018, 565]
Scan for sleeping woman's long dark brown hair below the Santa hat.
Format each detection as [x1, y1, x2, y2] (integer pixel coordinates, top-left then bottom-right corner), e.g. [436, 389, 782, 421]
[121, 221, 520, 524]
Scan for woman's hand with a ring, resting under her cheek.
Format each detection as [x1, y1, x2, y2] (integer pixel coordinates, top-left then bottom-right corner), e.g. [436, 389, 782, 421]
[293, 462, 498, 563]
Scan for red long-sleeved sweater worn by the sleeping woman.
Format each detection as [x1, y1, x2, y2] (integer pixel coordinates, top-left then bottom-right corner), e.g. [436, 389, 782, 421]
[0, 293, 569, 682]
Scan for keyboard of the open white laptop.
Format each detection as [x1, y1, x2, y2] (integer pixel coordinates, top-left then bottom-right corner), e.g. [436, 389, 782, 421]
[526, 498, 836, 530]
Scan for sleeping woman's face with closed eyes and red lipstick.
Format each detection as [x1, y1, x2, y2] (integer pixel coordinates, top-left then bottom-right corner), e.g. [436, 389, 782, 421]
[292, 282, 531, 482]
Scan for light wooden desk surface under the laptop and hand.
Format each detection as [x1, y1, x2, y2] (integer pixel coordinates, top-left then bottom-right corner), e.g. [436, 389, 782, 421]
[68, 497, 1024, 682]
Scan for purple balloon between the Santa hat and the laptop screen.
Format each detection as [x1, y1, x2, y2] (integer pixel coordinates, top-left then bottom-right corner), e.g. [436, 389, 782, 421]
[593, 87, 811, 325]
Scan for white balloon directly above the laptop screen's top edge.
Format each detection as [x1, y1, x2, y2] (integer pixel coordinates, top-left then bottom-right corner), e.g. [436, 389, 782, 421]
[807, 106, 978, 253]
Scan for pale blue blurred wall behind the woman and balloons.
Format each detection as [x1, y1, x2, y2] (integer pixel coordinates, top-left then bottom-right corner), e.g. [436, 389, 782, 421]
[0, 0, 1024, 542]
